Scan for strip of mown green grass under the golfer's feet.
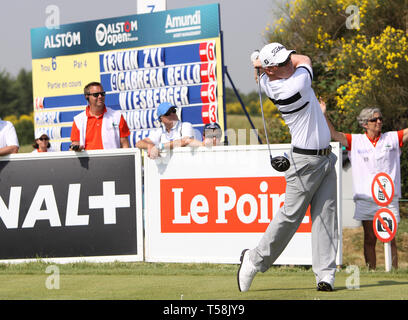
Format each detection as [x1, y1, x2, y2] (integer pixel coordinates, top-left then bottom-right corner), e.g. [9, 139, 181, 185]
[0, 261, 408, 300]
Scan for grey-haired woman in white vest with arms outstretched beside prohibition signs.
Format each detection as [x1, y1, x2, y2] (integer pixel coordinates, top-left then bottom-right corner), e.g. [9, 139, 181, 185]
[320, 100, 408, 269]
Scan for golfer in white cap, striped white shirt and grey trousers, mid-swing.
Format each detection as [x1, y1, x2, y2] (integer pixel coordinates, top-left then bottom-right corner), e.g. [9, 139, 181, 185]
[238, 43, 338, 291]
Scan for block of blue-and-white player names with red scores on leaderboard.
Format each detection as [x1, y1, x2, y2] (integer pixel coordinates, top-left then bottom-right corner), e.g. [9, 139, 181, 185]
[99, 42, 217, 140]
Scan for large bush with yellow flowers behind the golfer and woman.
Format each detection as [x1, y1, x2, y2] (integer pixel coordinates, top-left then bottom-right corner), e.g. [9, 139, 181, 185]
[264, 0, 408, 197]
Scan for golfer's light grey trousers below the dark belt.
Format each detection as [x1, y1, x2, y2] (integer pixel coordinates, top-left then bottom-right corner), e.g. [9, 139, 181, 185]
[249, 152, 338, 286]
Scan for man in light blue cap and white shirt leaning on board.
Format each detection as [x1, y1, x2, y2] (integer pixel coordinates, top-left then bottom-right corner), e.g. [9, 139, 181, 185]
[136, 102, 202, 159]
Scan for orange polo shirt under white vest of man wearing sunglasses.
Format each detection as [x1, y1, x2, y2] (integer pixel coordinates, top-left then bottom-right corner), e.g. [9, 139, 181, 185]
[71, 106, 130, 150]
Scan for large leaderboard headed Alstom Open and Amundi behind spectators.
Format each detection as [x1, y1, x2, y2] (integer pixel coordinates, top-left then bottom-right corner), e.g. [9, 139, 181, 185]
[31, 4, 224, 150]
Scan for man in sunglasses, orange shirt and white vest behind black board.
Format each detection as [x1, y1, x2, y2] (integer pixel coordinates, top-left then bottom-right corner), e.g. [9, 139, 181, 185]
[70, 82, 130, 151]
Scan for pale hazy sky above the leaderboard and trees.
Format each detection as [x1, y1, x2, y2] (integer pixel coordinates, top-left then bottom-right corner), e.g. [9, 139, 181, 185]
[0, 0, 276, 93]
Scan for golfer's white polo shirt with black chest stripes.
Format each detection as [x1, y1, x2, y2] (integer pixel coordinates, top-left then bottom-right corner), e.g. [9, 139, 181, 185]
[261, 64, 331, 149]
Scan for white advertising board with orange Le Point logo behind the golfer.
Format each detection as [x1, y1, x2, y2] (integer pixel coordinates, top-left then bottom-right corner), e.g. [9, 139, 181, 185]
[144, 143, 342, 265]
